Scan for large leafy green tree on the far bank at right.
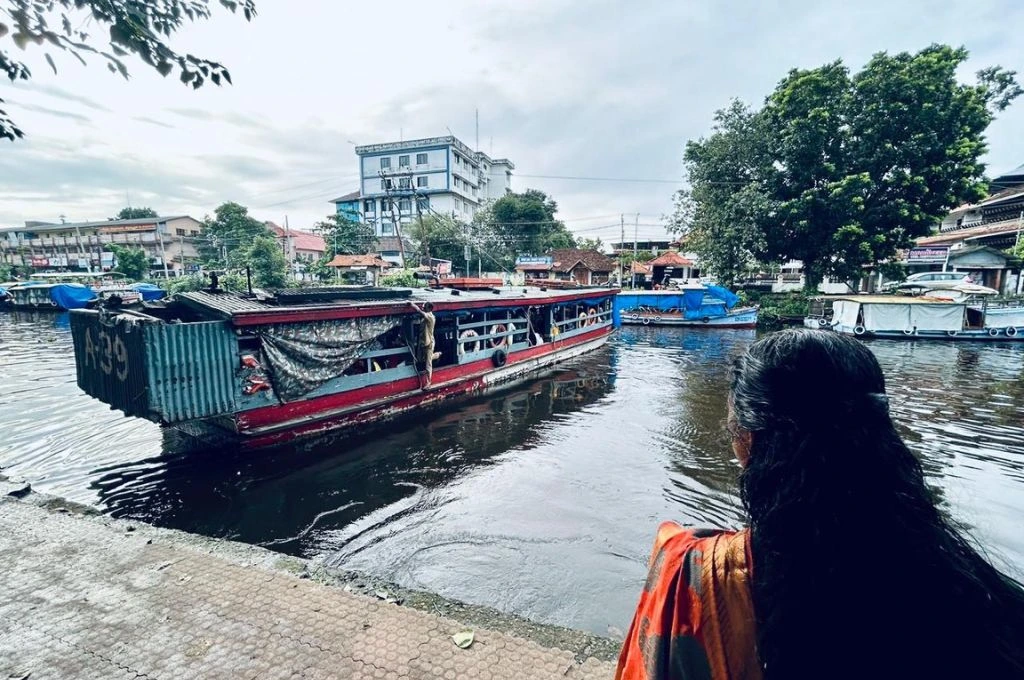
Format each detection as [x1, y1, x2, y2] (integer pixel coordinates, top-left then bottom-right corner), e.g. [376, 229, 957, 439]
[676, 45, 1022, 288]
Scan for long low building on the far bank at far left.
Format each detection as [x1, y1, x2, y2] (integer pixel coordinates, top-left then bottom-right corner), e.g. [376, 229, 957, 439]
[0, 215, 203, 275]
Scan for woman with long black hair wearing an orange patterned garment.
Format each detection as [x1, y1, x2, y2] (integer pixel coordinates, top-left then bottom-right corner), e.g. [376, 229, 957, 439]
[616, 330, 1024, 680]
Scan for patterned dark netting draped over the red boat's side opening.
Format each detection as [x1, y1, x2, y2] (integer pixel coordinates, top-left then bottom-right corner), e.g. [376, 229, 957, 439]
[259, 316, 401, 401]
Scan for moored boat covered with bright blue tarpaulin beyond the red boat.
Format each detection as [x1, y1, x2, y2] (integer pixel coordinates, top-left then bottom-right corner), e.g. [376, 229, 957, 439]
[615, 284, 758, 328]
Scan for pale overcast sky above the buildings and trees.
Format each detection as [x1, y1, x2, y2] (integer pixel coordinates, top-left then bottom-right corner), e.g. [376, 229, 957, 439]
[0, 0, 1024, 241]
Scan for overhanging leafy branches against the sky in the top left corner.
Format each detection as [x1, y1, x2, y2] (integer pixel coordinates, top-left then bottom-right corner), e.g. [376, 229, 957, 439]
[0, 0, 256, 141]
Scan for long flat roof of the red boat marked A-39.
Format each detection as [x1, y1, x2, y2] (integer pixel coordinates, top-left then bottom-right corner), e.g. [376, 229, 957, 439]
[174, 286, 617, 326]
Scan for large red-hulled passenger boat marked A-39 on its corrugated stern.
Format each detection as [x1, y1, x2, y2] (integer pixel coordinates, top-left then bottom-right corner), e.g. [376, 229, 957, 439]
[71, 286, 617, 445]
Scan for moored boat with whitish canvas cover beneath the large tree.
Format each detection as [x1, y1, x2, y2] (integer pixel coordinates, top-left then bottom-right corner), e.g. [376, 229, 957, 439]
[804, 284, 1024, 342]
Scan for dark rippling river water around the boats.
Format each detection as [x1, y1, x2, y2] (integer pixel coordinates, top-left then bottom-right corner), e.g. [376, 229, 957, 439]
[0, 312, 1024, 635]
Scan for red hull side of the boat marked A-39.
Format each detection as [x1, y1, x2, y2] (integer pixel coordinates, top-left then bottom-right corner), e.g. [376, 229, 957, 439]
[234, 325, 612, 445]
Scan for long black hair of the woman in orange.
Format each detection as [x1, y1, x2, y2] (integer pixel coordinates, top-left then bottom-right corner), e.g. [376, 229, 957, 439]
[730, 330, 1024, 679]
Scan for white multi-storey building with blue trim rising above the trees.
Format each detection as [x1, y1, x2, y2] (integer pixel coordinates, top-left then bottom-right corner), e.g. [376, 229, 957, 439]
[355, 136, 515, 236]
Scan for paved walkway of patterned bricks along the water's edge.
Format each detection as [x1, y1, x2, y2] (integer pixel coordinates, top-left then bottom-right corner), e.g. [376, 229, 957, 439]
[0, 496, 614, 680]
